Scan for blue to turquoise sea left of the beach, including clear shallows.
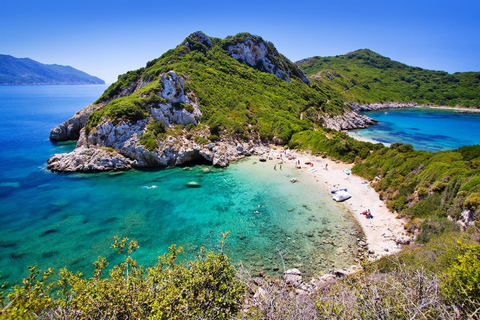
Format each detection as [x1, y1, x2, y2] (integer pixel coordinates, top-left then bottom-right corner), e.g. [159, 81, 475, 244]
[0, 86, 361, 284]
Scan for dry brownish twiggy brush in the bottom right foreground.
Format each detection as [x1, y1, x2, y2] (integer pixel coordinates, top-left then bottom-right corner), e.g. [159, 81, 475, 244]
[317, 265, 455, 320]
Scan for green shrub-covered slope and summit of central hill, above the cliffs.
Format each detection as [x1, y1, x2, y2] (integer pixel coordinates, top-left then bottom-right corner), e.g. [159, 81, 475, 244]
[88, 33, 344, 142]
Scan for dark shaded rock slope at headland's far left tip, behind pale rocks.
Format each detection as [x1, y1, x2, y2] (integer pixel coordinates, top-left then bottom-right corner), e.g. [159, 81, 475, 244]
[50, 104, 104, 141]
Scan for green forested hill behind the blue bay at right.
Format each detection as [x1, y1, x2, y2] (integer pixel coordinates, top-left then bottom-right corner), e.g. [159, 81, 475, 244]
[296, 49, 480, 107]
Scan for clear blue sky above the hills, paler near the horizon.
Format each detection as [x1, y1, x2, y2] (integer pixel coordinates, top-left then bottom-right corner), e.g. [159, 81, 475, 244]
[0, 0, 480, 83]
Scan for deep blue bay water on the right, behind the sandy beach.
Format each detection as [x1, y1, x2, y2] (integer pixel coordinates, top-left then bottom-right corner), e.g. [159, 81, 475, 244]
[350, 108, 480, 152]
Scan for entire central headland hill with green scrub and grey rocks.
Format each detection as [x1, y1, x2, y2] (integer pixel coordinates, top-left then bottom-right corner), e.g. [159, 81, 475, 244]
[49, 32, 373, 171]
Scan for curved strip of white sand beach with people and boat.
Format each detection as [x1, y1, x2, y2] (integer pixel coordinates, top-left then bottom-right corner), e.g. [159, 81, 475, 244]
[270, 147, 407, 259]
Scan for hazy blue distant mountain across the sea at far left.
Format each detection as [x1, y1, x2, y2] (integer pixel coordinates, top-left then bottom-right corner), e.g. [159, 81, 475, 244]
[0, 54, 105, 85]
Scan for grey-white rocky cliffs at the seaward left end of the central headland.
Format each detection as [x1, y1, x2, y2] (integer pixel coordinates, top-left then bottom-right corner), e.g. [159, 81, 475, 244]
[47, 71, 263, 172]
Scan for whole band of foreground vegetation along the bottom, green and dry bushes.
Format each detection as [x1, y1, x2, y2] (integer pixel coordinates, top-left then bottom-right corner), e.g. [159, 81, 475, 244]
[0, 234, 480, 320]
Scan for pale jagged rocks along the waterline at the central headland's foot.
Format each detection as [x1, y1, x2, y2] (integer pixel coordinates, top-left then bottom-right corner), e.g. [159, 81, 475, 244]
[48, 125, 267, 172]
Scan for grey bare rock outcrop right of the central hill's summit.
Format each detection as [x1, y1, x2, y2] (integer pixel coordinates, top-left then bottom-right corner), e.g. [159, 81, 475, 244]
[227, 34, 310, 85]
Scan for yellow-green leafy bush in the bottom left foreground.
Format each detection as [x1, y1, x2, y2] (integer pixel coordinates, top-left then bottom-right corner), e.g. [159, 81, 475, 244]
[0, 237, 244, 319]
